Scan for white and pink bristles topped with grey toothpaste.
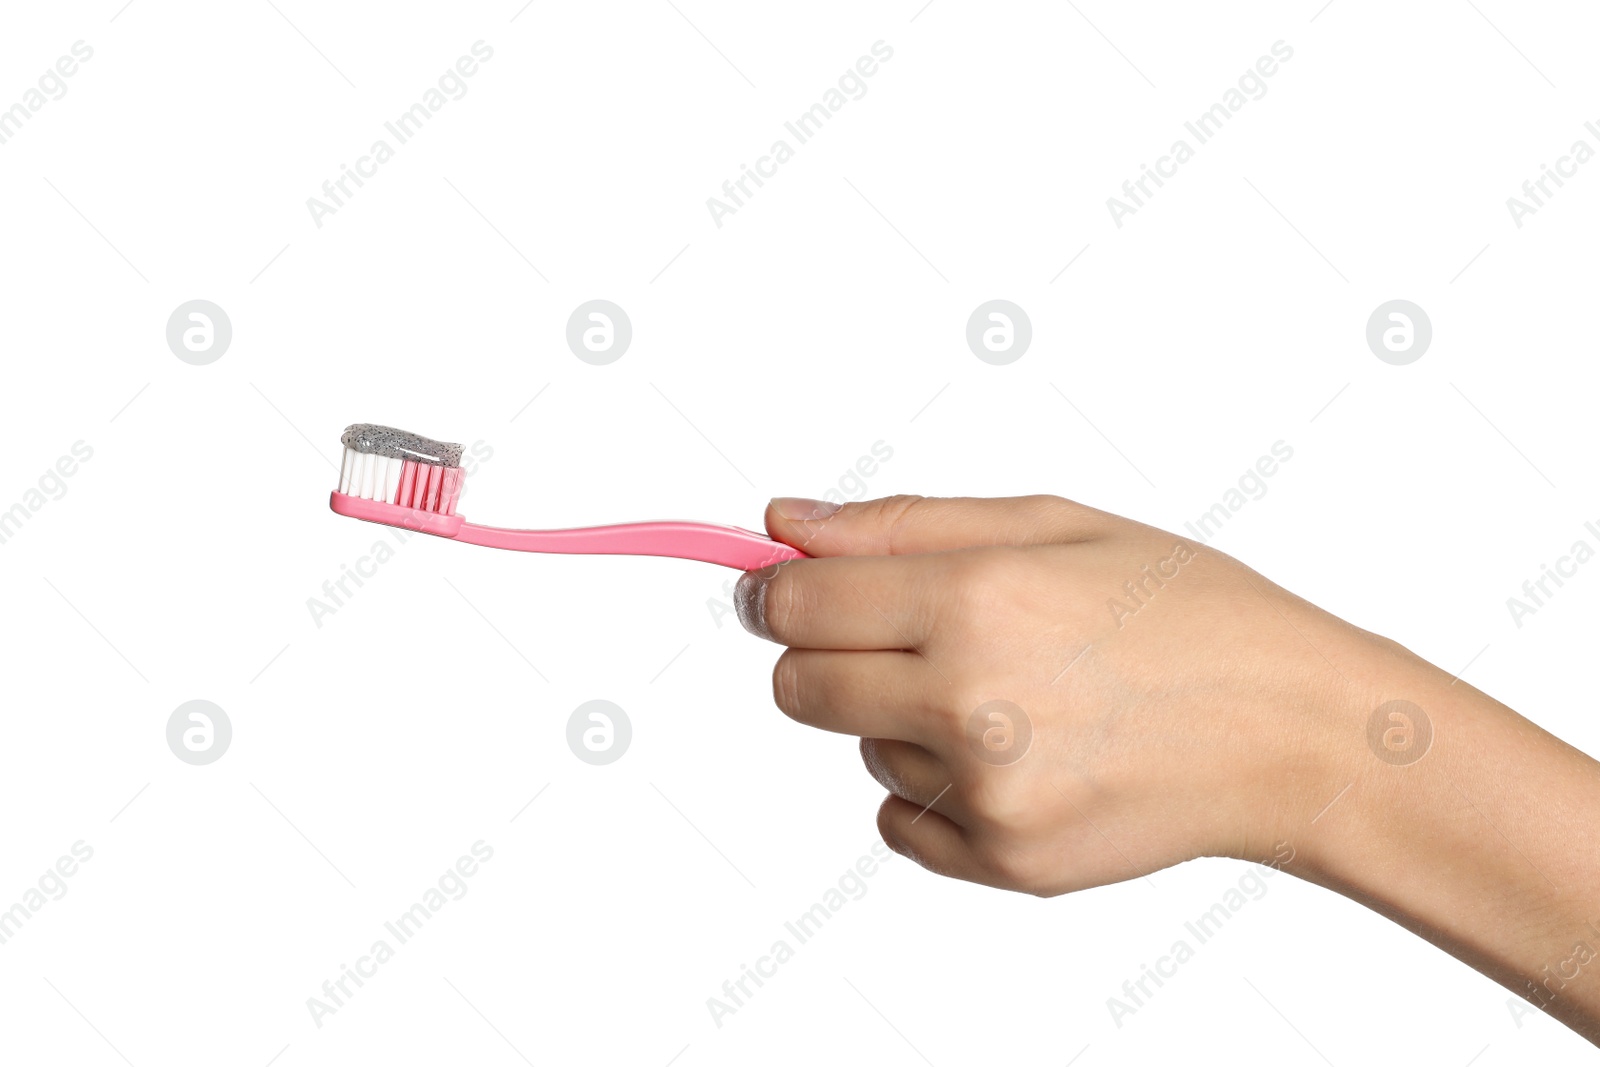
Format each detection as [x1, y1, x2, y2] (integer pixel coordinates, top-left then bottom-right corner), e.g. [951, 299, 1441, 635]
[339, 422, 462, 515]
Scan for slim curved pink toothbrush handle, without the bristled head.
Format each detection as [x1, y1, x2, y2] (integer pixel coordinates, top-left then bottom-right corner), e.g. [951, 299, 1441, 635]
[454, 523, 805, 571]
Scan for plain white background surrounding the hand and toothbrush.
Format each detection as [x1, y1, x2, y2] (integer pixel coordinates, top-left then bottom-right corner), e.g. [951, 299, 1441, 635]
[0, 0, 1600, 1067]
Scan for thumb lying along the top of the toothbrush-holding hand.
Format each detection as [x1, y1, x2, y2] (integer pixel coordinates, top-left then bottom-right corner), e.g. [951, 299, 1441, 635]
[766, 496, 1112, 555]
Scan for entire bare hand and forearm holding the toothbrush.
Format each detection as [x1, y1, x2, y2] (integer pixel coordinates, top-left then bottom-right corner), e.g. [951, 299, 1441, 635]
[736, 496, 1600, 1045]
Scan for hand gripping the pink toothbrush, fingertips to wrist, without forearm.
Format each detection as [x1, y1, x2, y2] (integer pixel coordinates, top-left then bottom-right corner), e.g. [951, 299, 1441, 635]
[738, 498, 1378, 894]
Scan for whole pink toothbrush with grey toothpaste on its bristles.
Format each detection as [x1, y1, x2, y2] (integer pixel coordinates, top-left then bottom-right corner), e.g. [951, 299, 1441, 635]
[328, 422, 805, 571]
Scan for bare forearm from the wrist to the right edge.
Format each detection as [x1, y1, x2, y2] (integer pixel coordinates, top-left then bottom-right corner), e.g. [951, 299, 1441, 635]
[1290, 649, 1600, 1043]
